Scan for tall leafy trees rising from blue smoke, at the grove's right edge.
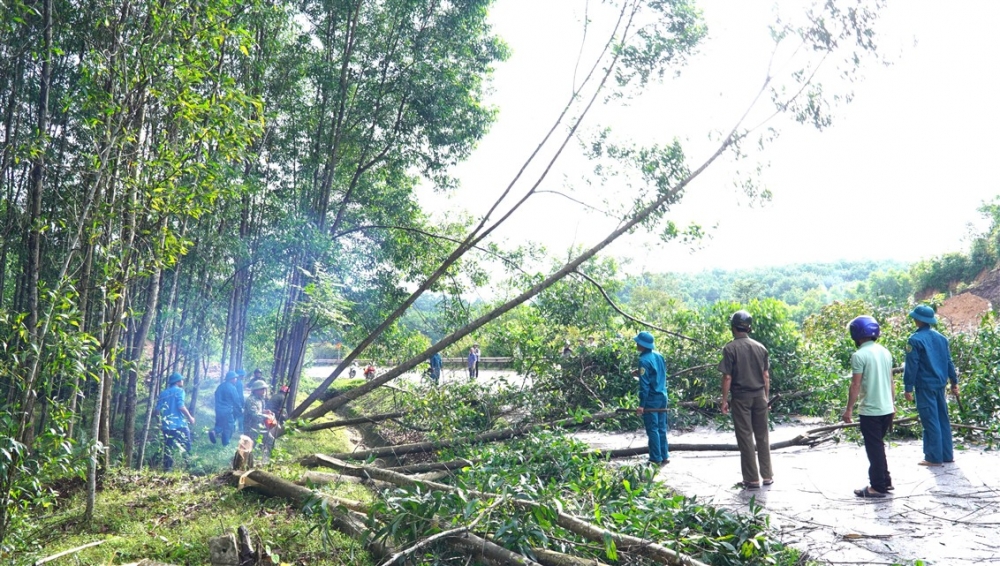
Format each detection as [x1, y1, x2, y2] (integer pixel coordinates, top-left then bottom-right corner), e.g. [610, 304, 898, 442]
[258, 0, 505, 410]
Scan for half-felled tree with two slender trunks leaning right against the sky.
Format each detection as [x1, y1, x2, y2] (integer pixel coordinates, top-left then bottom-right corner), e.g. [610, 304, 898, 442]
[290, 1, 878, 426]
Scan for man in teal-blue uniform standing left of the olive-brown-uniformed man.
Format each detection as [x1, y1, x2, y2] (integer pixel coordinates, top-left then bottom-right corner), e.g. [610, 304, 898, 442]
[632, 332, 670, 465]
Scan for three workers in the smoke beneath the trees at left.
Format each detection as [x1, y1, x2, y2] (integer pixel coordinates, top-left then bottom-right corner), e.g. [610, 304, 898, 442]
[157, 369, 288, 471]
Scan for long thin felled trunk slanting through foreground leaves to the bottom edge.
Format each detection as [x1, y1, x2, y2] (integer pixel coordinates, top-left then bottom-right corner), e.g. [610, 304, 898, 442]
[314, 454, 706, 566]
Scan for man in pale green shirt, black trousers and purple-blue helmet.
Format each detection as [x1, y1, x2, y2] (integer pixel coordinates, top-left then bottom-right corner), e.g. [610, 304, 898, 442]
[842, 316, 896, 498]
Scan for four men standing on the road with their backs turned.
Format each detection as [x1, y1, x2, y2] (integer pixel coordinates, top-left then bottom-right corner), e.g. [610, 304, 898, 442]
[633, 305, 958, 498]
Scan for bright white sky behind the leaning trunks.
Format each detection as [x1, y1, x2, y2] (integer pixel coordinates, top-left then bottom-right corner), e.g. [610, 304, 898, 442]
[424, 0, 1000, 272]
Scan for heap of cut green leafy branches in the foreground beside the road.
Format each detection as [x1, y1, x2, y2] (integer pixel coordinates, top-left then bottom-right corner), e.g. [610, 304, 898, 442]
[374, 433, 786, 565]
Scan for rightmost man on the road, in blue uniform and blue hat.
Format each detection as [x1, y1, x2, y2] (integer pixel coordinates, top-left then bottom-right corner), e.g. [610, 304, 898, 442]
[903, 305, 958, 466]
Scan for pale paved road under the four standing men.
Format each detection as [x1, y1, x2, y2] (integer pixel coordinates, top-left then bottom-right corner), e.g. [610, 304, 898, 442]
[578, 425, 1000, 566]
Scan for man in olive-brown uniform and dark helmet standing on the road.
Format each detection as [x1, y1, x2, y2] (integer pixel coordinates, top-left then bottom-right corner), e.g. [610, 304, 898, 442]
[719, 310, 774, 489]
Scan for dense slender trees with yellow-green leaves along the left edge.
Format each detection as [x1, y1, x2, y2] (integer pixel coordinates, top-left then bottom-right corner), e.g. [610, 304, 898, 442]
[0, 0, 260, 539]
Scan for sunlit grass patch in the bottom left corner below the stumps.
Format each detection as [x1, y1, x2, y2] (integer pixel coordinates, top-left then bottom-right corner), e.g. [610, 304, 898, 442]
[23, 469, 371, 566]
